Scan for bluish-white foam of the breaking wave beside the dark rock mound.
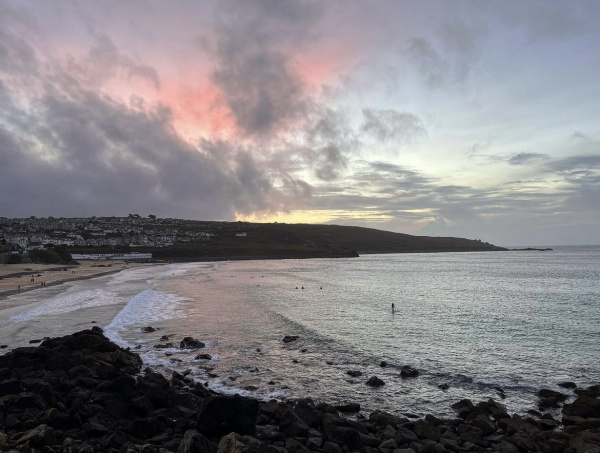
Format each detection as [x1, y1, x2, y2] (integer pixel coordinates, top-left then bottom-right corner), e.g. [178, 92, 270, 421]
[104, 289, 186, 347]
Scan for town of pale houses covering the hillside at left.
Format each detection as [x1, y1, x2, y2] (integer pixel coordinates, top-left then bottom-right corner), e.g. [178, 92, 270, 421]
[0, 214, 251, 253]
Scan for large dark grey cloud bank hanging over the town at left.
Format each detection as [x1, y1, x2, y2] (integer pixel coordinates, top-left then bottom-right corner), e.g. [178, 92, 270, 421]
[0, 74, 280, 219]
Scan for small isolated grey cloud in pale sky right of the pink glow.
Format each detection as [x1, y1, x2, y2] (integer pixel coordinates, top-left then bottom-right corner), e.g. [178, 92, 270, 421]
[360, 109, 427, 144]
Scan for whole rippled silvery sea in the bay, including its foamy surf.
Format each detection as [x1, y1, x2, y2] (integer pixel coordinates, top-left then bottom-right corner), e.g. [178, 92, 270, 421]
[0, 246, 600, 417]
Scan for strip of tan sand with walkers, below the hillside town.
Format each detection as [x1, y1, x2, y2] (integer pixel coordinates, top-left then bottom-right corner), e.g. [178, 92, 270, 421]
[0, 260, 151, 300]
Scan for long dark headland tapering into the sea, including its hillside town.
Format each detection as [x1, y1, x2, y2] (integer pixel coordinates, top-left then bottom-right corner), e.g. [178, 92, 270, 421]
[0, 214, 508, 262]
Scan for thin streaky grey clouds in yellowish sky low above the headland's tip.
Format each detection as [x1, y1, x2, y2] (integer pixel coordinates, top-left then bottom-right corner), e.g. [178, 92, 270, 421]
[315, 158, 584, 245]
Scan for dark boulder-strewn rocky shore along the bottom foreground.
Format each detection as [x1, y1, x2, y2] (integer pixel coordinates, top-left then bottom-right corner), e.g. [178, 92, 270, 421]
[0, 327, 600, 453]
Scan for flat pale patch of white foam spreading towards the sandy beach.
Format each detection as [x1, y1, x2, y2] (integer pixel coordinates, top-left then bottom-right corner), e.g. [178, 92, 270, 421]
[10, 288, 125, 322]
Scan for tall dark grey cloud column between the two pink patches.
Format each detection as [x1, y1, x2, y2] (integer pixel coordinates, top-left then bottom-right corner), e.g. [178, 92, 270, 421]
[204, 0, 318, 135]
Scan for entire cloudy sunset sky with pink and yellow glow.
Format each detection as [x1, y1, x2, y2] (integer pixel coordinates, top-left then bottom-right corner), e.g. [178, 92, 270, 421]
[0, 0, 600, 246]
